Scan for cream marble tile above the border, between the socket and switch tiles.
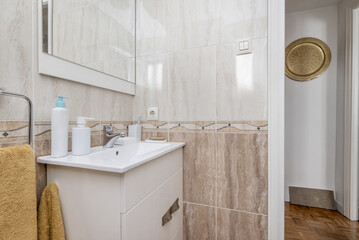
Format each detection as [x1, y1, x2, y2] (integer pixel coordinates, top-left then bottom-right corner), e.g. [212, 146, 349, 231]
[168, 47, 216, 121]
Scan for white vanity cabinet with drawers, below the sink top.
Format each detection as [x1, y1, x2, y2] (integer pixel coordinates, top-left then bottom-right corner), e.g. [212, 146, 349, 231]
[38, 142, 183, 240]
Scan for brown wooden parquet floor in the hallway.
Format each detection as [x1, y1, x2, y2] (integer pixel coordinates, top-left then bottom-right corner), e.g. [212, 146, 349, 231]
[285, 202, 359, 240]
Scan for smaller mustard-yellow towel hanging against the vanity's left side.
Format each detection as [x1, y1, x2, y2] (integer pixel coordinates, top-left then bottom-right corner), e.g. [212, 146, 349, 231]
[37, 182, 65, 240]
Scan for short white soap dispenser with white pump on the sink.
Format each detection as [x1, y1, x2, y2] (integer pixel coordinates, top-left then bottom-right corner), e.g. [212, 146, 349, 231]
[72, 117, 94, 156]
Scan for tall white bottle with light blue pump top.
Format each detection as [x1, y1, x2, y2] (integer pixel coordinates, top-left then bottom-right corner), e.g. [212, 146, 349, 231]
[51, 96, 69, 157]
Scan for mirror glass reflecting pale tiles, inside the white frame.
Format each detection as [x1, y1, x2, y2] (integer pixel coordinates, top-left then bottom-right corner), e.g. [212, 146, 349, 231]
[41, 0, 136, 85]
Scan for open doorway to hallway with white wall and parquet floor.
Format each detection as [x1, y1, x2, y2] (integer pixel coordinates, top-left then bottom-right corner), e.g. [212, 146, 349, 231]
[284, 0, 359, 239]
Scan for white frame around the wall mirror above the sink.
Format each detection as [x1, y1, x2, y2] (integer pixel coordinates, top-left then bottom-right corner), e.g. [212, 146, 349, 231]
[37, 0, 136, 95]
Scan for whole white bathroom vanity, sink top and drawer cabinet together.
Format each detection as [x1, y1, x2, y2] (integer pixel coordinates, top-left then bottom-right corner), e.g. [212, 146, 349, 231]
[37, 142, 184, 240]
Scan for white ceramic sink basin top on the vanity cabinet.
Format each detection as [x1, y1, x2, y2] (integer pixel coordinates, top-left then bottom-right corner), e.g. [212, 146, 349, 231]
[37, 142, 185, 173]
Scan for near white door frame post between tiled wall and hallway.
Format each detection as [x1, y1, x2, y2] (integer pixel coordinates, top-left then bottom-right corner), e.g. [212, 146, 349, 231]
[268, 0, 285, 237]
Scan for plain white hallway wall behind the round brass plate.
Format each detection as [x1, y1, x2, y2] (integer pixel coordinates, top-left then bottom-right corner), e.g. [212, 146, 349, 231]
[285, 6, 337, 201]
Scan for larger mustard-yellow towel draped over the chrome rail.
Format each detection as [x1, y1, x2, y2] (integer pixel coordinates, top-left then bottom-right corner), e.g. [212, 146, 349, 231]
[0, 145, 37, 240]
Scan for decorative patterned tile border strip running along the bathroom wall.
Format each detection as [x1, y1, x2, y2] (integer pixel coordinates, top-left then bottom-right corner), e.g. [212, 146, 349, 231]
[0, 121, 268, 143]
